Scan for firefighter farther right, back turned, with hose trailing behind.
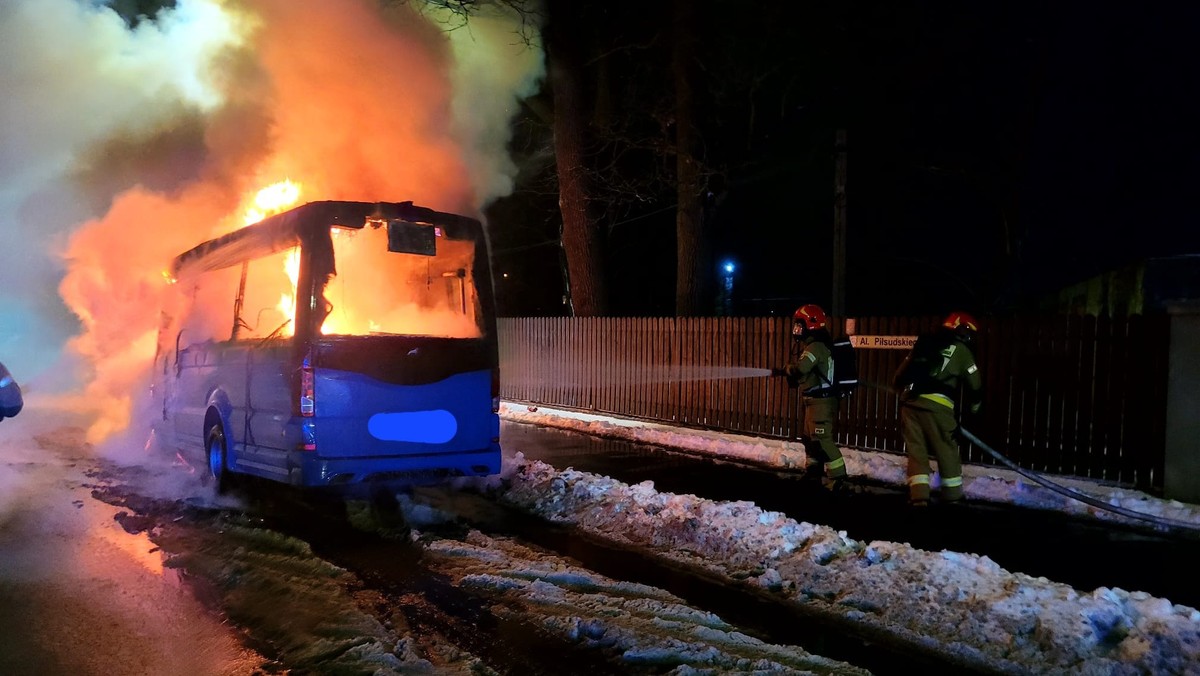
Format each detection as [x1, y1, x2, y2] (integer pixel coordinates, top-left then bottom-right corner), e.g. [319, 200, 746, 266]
[893, 312, 983, 507]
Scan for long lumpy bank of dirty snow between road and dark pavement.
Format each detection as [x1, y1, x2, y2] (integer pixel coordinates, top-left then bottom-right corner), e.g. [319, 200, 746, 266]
[477, 454, 1200, 674]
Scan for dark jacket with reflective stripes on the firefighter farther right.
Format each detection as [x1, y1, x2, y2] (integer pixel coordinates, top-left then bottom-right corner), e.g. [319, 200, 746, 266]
[893, 329, 983, 413]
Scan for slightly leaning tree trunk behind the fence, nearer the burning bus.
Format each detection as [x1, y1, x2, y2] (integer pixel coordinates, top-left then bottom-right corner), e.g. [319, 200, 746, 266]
[546, 2, 608, 317]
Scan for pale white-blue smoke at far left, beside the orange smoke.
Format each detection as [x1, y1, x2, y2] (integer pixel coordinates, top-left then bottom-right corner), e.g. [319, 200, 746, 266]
[0, 0, 246, 394]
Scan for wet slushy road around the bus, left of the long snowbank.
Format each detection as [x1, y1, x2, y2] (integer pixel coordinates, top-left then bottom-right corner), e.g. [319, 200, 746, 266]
[0, 413, 865, 675]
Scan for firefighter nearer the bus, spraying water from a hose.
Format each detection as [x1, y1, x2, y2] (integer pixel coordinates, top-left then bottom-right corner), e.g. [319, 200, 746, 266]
[772, 304, 846, 491]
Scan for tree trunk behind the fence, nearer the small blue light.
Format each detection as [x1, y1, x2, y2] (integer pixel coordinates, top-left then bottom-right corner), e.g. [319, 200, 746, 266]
[672, 0, 714, 317]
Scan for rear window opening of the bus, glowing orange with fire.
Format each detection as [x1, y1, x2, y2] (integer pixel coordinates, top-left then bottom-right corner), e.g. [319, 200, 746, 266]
[320, 223, 482, 337]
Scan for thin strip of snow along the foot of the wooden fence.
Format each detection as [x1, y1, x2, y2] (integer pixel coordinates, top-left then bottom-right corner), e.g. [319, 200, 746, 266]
[500, 402, 1200, 528]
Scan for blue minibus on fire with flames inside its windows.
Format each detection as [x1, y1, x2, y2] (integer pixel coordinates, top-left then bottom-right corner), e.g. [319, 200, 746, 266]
[152, 202, 500, 491]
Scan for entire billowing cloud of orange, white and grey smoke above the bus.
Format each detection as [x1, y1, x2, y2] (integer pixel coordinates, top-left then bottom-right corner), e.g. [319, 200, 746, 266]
[0, 0, 541, 449]
